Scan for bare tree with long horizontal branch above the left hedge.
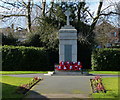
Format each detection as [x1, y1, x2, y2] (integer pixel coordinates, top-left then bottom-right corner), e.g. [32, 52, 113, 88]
[0, 0, 46, 32]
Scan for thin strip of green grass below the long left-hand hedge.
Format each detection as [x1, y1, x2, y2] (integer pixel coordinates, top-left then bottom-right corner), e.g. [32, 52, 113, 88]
[0, 71, 48, 75]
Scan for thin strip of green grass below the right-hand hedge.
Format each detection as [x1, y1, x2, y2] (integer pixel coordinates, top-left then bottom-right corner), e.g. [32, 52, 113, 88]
[89, 71, 120, 75]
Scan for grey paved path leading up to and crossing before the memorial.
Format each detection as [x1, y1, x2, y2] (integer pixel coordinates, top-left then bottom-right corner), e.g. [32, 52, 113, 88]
[2, 74, 119, 100]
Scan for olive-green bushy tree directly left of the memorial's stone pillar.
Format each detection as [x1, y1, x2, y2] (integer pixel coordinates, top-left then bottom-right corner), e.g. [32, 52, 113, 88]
[36, 16, 58, 50]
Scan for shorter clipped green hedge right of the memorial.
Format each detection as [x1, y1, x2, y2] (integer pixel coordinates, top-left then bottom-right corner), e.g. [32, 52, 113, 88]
[92, 48, 120, 71]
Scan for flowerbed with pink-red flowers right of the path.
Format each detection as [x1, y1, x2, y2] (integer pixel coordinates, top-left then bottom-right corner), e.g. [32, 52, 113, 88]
[90, 76, 106, 93]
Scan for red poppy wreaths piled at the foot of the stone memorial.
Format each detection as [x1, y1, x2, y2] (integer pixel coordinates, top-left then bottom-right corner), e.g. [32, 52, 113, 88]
[55, 61, 82, 71]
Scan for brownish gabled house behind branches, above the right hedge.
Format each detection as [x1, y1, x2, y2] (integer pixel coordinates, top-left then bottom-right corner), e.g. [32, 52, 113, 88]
[94, 21, 120, 47]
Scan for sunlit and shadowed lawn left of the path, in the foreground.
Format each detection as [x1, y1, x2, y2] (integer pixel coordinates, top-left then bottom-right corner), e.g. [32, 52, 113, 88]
[0, 76, 32, 100]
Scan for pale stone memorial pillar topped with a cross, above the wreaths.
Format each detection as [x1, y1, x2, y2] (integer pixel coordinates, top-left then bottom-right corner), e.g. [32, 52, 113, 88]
[59, 9, 77, 62]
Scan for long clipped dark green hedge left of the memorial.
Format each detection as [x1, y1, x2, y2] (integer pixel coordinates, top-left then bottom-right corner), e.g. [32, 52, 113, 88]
[1, 46, 53, 71]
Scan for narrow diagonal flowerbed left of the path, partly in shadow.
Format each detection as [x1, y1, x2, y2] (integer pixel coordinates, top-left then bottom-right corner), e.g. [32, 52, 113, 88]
[16, 77, 42, 94]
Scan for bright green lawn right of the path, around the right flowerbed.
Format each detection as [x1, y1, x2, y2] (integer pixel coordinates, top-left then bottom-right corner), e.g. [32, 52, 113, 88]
[92, 77, 120, 100]
